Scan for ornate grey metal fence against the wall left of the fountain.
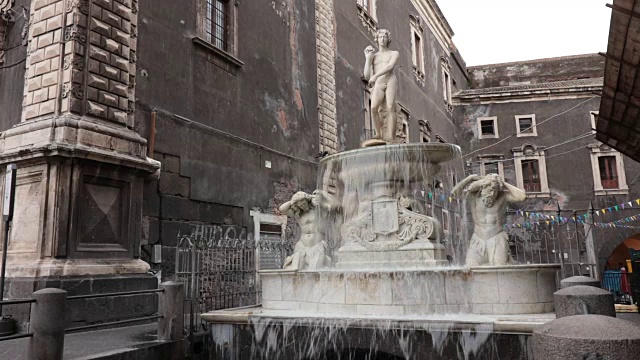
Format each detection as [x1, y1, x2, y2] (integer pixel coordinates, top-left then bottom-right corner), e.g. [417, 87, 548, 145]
[175, 225, 293, 331]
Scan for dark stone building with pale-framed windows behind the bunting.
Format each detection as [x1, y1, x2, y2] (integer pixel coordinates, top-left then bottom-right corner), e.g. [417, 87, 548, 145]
[454, 54, 640, 274]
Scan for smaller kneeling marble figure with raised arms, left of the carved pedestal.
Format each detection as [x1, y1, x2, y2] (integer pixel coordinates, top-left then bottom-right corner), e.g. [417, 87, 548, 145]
[280, 190, 338, 270]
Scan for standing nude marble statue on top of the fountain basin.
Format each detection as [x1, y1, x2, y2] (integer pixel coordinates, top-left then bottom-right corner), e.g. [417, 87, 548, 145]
[364, 29, 400, 143]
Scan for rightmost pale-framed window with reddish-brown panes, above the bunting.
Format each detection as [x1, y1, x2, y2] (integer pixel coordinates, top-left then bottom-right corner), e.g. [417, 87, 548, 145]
[589, 143, 629, 195]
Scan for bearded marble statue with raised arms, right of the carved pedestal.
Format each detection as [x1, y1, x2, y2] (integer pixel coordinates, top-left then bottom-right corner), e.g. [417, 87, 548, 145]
[452, 174, 527, 266]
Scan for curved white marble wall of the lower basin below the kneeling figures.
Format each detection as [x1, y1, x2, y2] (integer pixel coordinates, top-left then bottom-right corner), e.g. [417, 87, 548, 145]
[260, 262, 560, 316]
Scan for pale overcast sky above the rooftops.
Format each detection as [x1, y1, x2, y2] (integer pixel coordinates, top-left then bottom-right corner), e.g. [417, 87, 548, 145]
[436, 0, 613, 66]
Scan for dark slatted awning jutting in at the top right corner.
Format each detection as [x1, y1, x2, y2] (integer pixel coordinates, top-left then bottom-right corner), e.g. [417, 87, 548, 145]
[596, 0, 640, 161]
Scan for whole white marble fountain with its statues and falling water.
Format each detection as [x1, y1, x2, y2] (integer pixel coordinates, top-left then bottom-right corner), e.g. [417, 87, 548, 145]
[202, 32, 559, 359]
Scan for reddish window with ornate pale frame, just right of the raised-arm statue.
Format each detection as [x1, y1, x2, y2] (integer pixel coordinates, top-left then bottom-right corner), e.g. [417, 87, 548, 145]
[512, 144, 551, 197]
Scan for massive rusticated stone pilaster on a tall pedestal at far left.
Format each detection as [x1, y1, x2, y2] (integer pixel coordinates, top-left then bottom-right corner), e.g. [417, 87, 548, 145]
[0, 0, 158, 277]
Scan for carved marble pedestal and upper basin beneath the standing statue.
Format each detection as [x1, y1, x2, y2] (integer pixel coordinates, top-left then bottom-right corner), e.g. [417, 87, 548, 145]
[322, 143, 459, 269]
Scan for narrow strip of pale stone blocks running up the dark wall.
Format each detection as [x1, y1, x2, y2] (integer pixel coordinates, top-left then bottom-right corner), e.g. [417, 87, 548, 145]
[316, 0, 340, 154]
